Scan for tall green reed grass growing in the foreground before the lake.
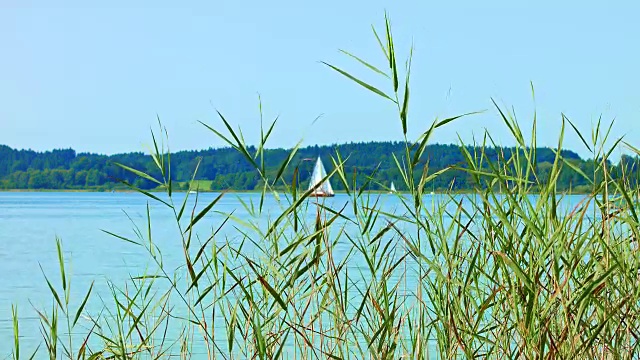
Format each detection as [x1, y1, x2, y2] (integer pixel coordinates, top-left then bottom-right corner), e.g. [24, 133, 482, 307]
[3, 12, 640, 360]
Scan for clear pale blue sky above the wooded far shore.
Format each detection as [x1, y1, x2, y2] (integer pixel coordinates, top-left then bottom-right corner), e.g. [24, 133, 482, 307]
[0, 0, 640, 157]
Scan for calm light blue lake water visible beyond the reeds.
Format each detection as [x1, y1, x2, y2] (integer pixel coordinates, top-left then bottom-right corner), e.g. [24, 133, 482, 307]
[0, 192, 592, 358]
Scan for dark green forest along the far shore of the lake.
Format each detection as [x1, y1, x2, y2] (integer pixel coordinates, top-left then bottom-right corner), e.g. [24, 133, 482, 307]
[0, 142, 638, 192]
